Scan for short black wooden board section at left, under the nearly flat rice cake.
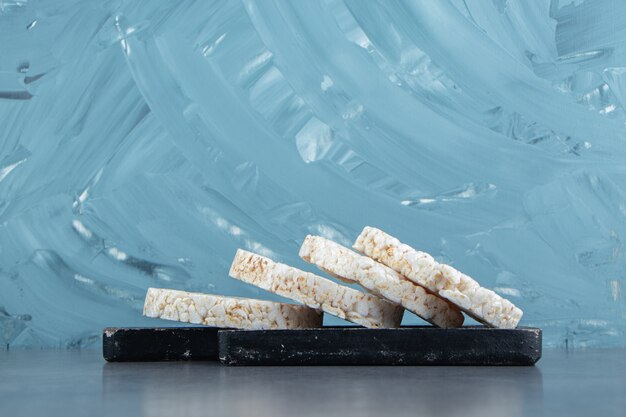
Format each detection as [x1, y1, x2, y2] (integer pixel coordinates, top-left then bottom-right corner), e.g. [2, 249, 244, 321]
[102, 327, 219, 362]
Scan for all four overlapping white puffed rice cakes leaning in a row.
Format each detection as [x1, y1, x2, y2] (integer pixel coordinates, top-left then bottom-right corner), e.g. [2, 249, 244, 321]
[144, 227, 522, 330]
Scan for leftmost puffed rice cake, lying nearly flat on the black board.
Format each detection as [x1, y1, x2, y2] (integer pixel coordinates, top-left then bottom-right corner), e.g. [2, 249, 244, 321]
[143, 288, 323, 330]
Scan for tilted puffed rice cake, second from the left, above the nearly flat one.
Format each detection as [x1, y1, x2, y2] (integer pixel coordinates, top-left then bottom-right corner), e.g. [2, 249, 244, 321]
[229, 249, 404, 328]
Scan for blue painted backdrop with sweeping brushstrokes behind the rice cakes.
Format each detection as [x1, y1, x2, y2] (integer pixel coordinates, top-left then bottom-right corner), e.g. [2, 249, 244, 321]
[0, 0, 626, 347]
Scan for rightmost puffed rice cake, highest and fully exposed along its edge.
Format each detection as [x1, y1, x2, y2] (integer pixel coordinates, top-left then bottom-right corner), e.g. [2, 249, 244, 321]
[353, 227, 523, 329]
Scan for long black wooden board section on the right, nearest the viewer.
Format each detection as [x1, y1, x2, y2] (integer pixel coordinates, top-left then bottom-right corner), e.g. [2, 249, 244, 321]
[218, 326, 541, 366]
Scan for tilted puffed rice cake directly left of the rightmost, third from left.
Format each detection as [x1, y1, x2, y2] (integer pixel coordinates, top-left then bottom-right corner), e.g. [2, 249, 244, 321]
[300, 235, 463, 328]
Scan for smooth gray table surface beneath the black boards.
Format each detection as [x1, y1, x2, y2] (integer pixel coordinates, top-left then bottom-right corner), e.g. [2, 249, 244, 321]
[0, 349, 626, 417]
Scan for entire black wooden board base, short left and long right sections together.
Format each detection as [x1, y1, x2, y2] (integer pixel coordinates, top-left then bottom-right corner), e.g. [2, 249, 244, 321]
[102, 326, 541, 365]
